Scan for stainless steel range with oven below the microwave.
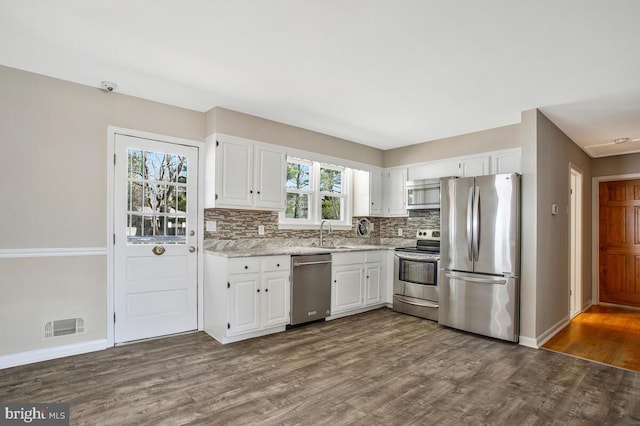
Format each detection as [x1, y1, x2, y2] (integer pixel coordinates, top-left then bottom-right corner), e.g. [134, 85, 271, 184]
[393, 229, 440, 321]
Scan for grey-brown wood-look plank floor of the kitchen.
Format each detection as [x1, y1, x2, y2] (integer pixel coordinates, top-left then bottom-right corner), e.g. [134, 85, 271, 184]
[0, 308, 640, 425]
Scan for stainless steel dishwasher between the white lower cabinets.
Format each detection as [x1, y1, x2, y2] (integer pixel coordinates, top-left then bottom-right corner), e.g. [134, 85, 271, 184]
[291, 254, 331, 325]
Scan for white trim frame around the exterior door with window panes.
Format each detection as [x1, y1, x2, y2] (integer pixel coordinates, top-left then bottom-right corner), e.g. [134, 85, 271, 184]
[106, 126, 204, 347]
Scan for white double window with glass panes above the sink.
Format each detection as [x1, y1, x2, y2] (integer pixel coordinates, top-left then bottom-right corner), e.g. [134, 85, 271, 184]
[280, 158, 351, 228]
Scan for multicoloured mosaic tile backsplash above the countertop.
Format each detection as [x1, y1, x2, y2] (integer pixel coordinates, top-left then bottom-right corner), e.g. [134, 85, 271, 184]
[204, 209, 440, 248]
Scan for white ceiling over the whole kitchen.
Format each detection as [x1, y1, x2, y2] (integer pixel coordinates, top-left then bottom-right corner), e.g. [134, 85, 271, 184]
[0, 0, 640, 156]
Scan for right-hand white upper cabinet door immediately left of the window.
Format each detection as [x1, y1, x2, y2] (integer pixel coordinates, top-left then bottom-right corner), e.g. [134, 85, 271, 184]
[255, 147, 286, 210]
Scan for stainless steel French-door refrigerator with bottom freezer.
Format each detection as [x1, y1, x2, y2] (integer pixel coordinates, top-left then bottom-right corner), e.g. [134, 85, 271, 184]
[438, 173, 520, 342]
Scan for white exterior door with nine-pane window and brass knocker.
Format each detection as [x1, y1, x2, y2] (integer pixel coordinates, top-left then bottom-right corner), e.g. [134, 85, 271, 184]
[114, 134, 198, 343]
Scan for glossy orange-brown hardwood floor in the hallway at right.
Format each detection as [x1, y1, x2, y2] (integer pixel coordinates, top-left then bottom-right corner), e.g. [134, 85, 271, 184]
[543, 305, 640, 371]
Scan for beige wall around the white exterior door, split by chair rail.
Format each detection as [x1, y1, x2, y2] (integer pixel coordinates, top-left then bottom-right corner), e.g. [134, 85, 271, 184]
[0, 66, 205, 355]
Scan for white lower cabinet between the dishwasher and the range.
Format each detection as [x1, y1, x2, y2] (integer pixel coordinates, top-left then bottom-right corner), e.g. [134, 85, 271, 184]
[331, 251, 387, 317]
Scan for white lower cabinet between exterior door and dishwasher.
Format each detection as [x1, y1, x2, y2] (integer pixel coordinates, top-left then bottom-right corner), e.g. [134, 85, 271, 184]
[204, 253, 291, 343]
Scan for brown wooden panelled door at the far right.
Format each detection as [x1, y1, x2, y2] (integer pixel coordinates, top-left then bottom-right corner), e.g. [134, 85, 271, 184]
[599, 179, 640, 307]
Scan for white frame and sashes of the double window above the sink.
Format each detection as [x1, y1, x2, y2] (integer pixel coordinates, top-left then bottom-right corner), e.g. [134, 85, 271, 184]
[278, 156, 353, 230]
